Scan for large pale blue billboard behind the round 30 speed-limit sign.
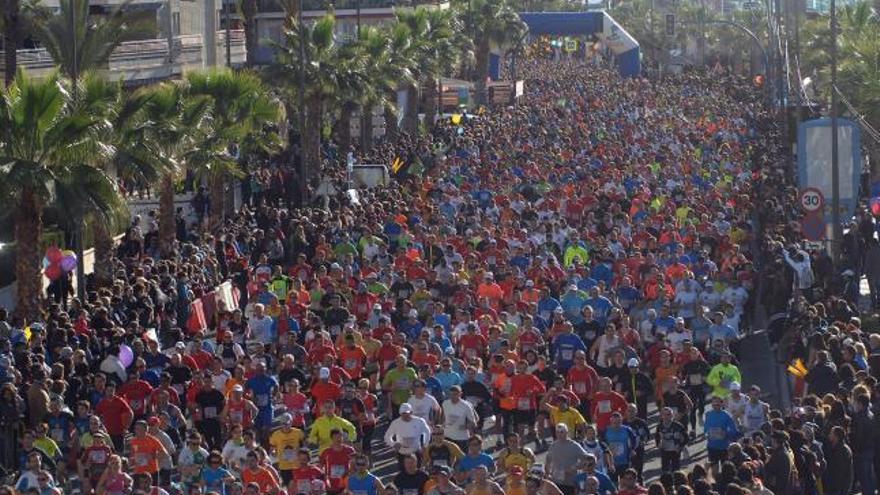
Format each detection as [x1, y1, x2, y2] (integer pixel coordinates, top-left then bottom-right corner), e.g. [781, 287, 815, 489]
[797, 119, 862, 221]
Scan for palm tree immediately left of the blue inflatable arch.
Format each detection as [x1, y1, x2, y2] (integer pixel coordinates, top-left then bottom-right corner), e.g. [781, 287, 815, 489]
[464, 0, 528, 104]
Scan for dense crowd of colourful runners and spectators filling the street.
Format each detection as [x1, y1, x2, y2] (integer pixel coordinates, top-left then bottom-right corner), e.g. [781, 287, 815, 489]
[0, 49, 880, 495]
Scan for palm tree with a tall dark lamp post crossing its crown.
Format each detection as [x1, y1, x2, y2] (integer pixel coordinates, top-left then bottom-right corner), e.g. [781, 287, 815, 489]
[266, 15, 346, 192]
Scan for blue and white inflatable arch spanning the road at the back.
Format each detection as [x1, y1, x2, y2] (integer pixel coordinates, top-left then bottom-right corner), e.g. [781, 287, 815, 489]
[519, 11, 641, 77]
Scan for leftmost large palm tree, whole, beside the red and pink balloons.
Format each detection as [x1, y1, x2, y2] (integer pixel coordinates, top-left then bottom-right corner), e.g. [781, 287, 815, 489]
[0, 71, 115, 319]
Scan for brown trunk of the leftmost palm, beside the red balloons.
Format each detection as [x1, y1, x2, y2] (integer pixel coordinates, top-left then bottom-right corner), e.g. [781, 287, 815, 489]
[15, 188, 43, 321]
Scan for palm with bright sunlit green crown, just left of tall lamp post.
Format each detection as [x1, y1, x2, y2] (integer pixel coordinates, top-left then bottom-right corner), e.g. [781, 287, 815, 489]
[186, 68, 283, 228]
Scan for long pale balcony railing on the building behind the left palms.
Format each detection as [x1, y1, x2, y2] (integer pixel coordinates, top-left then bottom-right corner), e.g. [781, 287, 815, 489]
[0, 30, 246, 85]
